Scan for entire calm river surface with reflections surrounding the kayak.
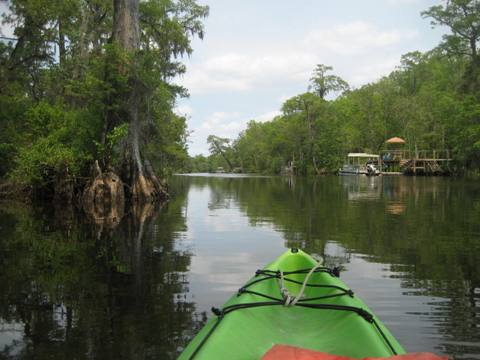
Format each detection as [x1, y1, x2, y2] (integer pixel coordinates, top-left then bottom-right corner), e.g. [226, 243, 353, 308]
[0, 174, 480, 359]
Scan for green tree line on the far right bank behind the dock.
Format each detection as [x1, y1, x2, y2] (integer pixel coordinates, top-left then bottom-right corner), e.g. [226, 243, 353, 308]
[190, 0, 480, 175]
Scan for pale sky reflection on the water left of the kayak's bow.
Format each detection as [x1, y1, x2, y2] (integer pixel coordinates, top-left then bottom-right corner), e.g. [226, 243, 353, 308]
[184, 183, 284, 311]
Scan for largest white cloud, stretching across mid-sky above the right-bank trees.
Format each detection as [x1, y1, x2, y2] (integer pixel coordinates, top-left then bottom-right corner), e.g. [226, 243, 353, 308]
[181, 20, 417, 96]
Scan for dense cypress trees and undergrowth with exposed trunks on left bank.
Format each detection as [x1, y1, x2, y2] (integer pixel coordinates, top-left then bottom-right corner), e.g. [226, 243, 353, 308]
[0, 0, 209, 207]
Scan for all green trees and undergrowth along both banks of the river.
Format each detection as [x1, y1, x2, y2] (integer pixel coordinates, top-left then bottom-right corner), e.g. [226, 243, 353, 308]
[0, 0, 480, 205]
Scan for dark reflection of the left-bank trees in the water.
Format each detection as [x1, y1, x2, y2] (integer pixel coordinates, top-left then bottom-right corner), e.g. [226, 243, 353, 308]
[0, 190, 205, 359]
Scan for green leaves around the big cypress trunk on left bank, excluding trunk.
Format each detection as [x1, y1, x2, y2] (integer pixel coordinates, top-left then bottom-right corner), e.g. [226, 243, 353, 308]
[0, 0, 208, 191]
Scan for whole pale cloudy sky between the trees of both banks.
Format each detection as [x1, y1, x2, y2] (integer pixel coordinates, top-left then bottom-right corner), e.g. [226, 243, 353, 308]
[176, 0, 445, 156]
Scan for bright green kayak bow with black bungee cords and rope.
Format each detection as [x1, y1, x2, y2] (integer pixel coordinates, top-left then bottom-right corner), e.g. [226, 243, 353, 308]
[179, 249, 405, 360]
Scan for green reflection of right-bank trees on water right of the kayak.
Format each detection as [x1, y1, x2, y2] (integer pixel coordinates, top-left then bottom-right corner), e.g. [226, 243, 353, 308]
[179, 176, 480, 358]
